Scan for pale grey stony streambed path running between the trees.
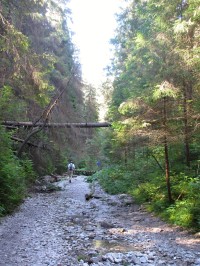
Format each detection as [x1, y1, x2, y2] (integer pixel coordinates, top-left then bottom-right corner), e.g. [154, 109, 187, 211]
[0, 176, 200, 266]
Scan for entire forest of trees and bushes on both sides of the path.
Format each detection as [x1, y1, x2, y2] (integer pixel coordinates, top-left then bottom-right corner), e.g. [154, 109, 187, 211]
[0, 0, 200, 230]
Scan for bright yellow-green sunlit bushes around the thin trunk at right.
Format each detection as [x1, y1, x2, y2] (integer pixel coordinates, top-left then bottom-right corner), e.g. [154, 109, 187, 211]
[130, 168, 200, 230]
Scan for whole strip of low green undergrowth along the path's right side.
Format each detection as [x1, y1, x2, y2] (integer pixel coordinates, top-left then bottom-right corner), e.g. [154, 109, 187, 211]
[88, 165, 200, 231]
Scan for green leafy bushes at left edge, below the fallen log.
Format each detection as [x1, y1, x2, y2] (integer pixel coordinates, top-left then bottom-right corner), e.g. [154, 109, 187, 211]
[0, 127, 35, 216]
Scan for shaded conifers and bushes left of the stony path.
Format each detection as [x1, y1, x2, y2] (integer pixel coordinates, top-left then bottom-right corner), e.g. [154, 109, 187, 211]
[0, 0, 98, 214]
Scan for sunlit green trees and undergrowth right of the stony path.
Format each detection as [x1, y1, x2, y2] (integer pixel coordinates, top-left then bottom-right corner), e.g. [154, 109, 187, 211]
[101, 0, 200, 229]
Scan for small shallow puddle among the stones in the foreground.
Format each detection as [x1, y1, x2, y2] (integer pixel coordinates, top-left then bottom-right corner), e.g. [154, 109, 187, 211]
[93, 240, 141, 252]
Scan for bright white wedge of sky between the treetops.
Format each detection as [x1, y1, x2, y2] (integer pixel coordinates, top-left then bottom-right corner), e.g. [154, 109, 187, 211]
[69, 0, 124, 86]
